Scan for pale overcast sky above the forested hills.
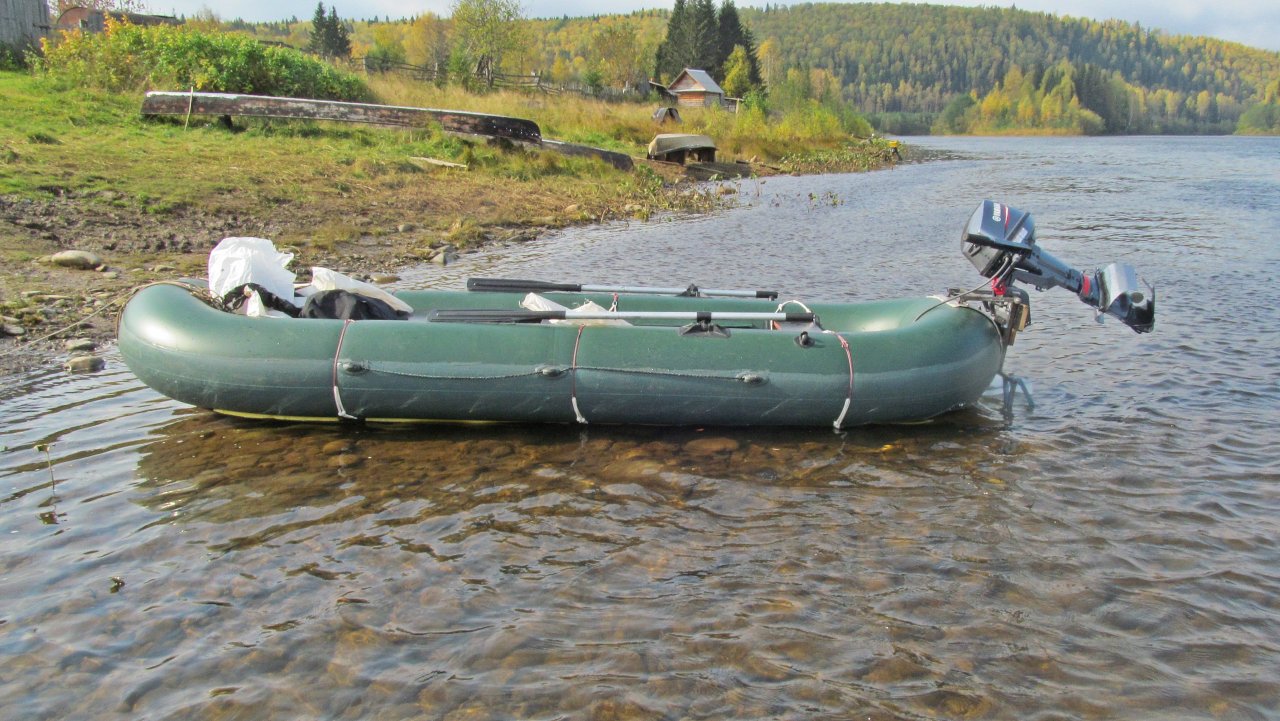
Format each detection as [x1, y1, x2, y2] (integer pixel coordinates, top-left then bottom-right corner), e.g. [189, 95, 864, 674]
[148, 0, 1280, 50]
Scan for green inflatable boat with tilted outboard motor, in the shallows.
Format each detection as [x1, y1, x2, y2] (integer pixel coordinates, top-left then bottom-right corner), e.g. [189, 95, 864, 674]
[119, 201, 1155, 428]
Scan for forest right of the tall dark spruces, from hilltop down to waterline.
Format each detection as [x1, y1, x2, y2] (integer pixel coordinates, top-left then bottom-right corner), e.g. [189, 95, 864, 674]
[741, 4, 1280, 133]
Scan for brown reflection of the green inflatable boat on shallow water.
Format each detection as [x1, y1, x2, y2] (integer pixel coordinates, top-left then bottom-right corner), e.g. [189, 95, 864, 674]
[133, 412, 1007, 532]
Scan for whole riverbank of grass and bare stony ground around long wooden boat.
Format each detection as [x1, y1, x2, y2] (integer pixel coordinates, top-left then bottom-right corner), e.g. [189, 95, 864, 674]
[0, 64, 901, 366]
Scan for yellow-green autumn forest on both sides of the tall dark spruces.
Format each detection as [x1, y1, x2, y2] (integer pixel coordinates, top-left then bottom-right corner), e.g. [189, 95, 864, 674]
[212, 0, 1280, 133]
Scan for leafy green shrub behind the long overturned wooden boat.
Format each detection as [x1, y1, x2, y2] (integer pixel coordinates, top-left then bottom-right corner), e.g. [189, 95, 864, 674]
[38, 19, 372, 101]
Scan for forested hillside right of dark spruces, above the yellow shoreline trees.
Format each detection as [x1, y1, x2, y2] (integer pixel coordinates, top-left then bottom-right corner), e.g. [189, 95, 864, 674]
[740, 4, 1280, 111]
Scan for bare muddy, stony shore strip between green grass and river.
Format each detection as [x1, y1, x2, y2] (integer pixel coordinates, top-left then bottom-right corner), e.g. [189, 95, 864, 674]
[0, 156, 724, 374]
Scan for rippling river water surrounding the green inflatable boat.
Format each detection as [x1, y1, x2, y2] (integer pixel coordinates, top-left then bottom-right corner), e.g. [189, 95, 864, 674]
[0, 133, 1280, 721]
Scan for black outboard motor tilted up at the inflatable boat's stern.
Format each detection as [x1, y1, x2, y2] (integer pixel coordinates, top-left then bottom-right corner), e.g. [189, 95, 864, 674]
[960, 200, 1156, 333]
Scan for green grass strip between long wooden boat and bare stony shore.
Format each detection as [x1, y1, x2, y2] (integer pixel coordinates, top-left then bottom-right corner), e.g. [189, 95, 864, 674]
[0, 73, 622, 221]
